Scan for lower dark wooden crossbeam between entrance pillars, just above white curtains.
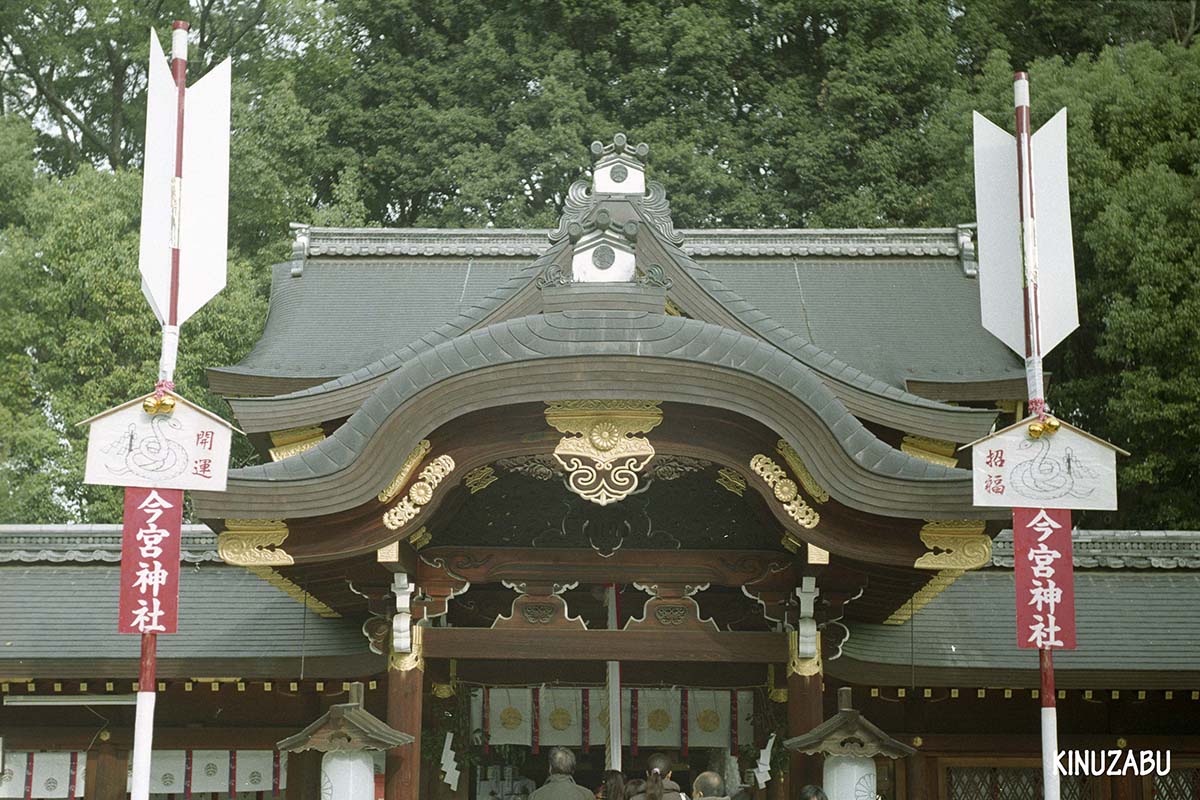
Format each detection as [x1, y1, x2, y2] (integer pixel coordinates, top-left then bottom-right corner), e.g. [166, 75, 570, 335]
[422, 627, 787, 663]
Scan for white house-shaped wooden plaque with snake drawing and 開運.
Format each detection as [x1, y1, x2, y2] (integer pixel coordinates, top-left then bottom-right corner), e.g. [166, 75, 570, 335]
[83, 395, 233, 492]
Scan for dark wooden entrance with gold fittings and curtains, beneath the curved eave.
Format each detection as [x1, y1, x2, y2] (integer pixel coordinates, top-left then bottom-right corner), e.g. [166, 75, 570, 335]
[208, 401, 974, 800]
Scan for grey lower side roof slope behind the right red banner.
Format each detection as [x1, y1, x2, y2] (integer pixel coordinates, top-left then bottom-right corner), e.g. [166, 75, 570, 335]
[827, 571, 1200, 687]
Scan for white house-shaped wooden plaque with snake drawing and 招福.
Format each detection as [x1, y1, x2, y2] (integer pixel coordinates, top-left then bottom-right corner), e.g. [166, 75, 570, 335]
[971, 417, 1124, 511]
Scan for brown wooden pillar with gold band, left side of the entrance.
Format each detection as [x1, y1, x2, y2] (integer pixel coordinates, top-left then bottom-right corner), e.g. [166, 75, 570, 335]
[384, 625, 425, 800]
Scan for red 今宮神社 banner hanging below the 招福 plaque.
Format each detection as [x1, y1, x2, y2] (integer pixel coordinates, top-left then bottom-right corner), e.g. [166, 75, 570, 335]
[1013, 509, 1075, 650]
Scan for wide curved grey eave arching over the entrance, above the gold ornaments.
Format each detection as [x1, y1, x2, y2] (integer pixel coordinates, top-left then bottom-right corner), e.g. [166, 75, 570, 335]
[193, 299, 1003, 518]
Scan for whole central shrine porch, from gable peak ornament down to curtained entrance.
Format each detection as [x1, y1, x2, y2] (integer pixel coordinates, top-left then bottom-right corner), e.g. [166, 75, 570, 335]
[194, 134, 1003, 800]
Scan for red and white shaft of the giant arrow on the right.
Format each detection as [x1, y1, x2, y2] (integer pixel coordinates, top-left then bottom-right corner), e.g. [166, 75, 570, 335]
[1013, 72, 1058, 800]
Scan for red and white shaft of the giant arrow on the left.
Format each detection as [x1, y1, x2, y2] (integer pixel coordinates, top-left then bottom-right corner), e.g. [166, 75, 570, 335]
[130, 19, 190, 800]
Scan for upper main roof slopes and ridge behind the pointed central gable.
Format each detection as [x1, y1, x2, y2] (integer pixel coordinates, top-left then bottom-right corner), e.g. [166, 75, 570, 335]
[214, 228, 1015, 389]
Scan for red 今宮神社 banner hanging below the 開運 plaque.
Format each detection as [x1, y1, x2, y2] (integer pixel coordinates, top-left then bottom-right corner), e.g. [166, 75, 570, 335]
[116, 486, 184, 633]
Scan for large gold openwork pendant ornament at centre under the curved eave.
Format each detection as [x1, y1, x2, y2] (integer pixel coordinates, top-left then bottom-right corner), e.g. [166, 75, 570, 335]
[546, 401, 662, 505]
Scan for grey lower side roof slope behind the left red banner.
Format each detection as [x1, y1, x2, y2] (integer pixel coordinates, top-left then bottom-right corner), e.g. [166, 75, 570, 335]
[0, 564, 370, 678]
